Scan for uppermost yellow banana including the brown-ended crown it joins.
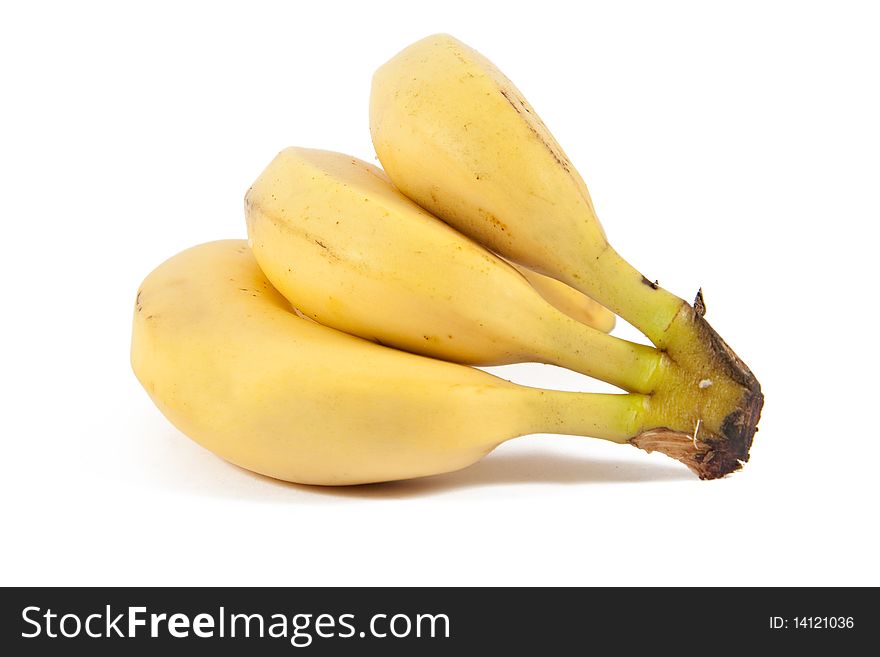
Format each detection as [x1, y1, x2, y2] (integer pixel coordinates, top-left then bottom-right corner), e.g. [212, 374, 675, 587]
[370, 35, 763, 474]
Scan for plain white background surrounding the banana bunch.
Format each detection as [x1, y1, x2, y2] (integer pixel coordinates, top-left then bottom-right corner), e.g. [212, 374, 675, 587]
[0, 0, 880, 584]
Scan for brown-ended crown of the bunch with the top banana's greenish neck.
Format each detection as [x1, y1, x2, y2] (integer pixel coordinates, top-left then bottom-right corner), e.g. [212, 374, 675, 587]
[568, 241, 764, 479]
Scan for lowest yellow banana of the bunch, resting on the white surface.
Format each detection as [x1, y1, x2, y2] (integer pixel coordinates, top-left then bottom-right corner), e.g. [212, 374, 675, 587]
[131, 240, 712, 485]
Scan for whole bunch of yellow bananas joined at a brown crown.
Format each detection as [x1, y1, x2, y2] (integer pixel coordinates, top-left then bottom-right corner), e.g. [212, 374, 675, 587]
[132, 35, 763, 485]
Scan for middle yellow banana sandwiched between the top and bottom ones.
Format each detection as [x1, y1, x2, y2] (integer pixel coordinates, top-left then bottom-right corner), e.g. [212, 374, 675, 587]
[245, 148, 648, 392]
